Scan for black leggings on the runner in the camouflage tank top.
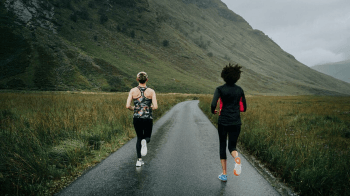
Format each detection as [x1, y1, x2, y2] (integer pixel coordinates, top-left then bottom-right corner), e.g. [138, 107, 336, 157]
[133, 118, 153, 158]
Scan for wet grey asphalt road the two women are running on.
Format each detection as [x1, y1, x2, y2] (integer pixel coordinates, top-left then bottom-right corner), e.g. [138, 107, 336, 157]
[57, 101, 279, 196]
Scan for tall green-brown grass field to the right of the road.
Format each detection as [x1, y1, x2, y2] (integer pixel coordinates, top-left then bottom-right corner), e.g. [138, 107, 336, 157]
[200, 96, 350, 195]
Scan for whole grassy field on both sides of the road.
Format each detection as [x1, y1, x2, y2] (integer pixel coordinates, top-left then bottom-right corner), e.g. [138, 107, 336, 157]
[0, 92, 350, 195]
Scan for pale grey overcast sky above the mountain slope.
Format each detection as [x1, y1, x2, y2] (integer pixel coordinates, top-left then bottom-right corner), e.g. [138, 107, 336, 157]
[222, 0, 350, 66]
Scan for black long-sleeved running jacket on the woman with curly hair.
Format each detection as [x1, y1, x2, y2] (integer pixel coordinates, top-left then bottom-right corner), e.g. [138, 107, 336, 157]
[211, 84, 247, 126]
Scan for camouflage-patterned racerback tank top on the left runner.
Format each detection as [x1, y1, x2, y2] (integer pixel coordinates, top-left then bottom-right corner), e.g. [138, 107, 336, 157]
[134, 86, 153, 119]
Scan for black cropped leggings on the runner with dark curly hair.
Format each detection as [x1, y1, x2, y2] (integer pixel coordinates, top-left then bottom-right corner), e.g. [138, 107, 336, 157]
[218, 124, 241, 159]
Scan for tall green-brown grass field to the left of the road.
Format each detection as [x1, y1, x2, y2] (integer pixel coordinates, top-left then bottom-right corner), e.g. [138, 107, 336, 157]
[0, 92, 197, 195]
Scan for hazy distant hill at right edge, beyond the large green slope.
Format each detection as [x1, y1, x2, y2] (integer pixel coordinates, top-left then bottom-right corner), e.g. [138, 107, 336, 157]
[311, 60, 350, 83]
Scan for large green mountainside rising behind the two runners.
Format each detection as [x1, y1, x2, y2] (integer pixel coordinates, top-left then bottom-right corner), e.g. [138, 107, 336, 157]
[0, 0, 350, 95]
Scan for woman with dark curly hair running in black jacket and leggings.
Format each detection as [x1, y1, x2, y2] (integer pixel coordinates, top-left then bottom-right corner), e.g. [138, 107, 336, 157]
[211, 64, 247, 182]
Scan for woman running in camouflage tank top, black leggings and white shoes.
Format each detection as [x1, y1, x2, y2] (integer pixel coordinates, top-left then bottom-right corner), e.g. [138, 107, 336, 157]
[126, 72, 158, 167]
